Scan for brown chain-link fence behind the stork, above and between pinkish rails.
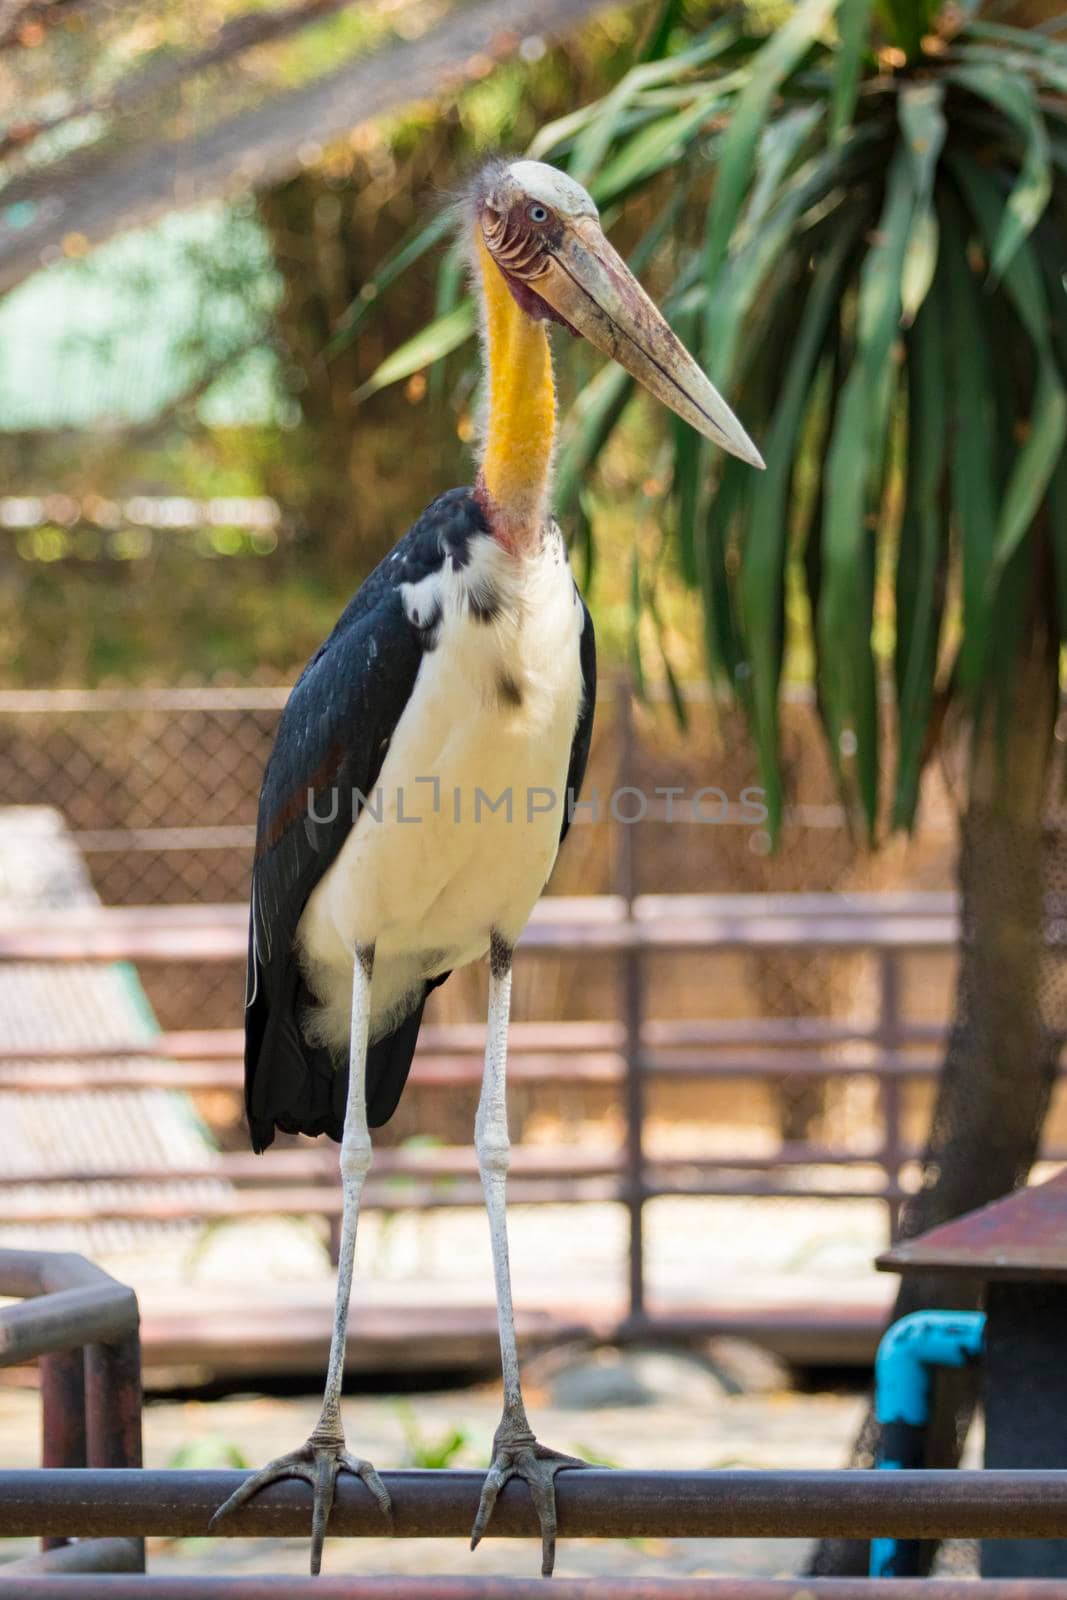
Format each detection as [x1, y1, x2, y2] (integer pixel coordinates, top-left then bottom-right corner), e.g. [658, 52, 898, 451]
[0, 683, 953, 1138]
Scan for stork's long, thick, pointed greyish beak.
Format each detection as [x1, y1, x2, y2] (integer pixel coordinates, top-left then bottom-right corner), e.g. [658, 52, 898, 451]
[530, 216, 763, 467]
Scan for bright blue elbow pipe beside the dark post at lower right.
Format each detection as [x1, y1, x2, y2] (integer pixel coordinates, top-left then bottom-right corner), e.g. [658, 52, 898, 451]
[870, 1310, 985, 1578]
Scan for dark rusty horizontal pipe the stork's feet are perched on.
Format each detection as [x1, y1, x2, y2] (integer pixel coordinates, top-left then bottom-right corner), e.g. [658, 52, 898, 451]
[0, 1469, 1067, 1539]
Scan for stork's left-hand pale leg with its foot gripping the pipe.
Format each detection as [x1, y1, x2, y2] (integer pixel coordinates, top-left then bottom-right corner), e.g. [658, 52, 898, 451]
[211, 946, 392, 1574]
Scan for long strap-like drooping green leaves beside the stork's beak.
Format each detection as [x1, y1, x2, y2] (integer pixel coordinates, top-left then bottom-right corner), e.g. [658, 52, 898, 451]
[356, 0, 1067, 837]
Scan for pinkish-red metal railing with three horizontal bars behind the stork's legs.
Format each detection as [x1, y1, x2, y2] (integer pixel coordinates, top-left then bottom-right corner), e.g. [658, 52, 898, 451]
[0, 889, 1017, 1286]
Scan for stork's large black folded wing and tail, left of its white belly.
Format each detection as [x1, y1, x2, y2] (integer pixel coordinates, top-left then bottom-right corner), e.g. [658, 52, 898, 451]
[245, 488, 486, 1150]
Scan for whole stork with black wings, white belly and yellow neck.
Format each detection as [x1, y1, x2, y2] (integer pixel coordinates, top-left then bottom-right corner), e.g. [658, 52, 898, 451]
[218, 160, 763, 1573]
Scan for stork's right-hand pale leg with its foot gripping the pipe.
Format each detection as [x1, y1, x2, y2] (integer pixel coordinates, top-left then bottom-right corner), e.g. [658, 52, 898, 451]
[470, 933, 587, 1578]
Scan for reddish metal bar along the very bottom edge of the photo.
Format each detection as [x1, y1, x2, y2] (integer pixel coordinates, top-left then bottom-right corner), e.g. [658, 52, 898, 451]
[0, 1576, 1067, 1600]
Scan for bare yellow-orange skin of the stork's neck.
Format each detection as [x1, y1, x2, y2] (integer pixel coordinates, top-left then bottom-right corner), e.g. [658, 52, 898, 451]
[475, 229, 555, 552]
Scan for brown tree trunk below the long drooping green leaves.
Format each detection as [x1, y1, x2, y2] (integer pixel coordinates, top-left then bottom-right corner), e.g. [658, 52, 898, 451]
[809, 585, 1062, 1578]
